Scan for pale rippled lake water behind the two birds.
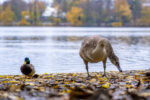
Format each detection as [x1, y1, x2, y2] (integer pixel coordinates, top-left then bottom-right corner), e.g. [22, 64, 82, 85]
[0, 27, 150, 75]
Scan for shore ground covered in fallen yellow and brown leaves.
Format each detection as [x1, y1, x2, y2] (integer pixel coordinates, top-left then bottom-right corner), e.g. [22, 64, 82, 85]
[0, 70, 150, 100]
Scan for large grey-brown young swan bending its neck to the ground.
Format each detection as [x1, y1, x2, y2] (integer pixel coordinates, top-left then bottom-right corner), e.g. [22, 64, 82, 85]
[79, 35, 122, 77]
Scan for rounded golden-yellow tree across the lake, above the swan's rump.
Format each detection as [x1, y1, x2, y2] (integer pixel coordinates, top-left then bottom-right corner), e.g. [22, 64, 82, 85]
[66, 7, 84, 26]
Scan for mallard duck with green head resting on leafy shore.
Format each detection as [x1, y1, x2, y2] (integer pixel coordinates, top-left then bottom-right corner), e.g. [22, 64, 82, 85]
[20, 57, 35, 78]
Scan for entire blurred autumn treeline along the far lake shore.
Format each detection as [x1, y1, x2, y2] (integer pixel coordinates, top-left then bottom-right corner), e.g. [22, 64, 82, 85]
[0, 0, 150, 27]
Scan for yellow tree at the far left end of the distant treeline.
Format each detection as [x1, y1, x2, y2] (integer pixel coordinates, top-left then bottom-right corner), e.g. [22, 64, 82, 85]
[0, 5, 15, 25]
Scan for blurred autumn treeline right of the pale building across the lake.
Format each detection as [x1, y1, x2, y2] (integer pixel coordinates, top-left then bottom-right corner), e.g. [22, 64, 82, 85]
[53, 0, 150, 26]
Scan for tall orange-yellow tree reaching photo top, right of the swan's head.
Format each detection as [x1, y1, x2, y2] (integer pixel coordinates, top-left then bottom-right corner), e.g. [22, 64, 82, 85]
[114, 0, 132, 24]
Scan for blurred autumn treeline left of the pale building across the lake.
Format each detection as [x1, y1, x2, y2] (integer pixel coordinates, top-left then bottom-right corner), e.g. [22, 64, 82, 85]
[0, 0, 46, 26]
